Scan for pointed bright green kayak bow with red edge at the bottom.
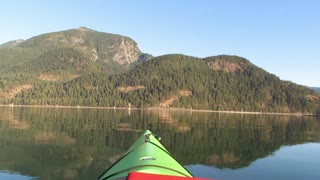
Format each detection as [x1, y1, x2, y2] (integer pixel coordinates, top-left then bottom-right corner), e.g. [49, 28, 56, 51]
[98, 130, 199, 180]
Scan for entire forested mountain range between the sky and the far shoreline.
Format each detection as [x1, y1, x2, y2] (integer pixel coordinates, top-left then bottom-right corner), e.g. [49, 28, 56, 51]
[0, 27, 320, 113]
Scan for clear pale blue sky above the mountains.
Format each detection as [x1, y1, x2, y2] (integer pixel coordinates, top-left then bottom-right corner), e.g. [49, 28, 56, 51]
[0, 0, 320, 87]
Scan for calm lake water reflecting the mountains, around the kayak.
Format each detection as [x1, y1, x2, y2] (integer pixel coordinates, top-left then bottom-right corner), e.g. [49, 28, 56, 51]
[0, 107, 320, 180]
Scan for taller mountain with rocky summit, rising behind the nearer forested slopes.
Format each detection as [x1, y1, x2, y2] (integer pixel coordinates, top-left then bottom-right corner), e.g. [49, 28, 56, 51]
[0, 27, 152, 89]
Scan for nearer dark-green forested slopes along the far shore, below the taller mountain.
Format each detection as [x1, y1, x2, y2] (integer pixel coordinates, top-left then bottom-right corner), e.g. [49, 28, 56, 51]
[1, 55, 320, 113]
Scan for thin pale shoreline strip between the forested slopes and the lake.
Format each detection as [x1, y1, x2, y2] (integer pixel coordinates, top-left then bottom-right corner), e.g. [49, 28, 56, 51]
[0, 104, 320, 116]
